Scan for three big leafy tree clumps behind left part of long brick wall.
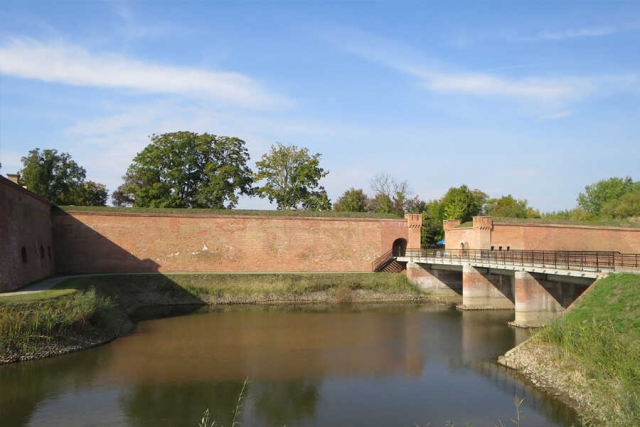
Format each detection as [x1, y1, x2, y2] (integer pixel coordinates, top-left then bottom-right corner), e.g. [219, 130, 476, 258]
[20, 132, 331, 210]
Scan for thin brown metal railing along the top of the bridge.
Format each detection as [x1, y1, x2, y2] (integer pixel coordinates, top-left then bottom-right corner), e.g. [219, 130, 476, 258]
[412, 249, 640, 271]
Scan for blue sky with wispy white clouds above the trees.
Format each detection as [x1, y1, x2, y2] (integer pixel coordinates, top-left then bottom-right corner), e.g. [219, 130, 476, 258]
[0, 0, 640, 212]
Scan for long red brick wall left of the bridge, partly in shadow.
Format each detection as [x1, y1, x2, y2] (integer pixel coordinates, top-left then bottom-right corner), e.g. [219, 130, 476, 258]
[53, 212, 407, 273]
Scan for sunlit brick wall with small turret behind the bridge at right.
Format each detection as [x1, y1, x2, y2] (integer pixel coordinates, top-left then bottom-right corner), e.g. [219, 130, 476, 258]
[445, 217, 640, 253]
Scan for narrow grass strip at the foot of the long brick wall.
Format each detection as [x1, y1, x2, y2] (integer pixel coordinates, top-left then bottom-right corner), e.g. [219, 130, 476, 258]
[57, 273, 421, 311]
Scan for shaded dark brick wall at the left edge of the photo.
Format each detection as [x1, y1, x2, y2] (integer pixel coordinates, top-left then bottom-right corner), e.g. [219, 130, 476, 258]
[0, 176, 55, 292]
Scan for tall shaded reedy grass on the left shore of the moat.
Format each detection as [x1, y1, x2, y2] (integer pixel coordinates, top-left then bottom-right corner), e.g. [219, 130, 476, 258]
[0, 288, 115, 356]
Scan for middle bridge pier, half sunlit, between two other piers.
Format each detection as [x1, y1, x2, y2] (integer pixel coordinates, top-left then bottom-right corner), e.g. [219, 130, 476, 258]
[460, 265, 515, 310]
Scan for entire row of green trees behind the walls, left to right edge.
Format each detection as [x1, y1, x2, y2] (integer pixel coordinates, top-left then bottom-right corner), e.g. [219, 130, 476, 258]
[11, 132, 640, 246]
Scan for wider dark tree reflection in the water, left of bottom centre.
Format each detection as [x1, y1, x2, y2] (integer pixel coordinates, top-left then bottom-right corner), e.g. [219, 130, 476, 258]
[120, 381, 245, 427]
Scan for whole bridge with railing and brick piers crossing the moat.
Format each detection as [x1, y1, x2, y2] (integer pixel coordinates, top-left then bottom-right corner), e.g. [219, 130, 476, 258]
[372, 249, 640, 327]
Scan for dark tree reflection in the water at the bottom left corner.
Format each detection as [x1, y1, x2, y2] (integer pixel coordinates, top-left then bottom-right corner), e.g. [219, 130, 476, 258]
[0, 349, 101, 427]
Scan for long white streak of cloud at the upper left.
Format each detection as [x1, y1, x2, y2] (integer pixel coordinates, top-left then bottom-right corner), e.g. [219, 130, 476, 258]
[0, 38, 292, 109]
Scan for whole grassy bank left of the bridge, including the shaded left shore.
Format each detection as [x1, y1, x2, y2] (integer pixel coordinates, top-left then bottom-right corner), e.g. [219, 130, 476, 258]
[0, 273, 423, 363]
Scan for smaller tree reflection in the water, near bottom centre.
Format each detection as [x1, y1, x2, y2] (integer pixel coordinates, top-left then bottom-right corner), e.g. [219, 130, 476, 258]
[251, 380, 320, 426]
